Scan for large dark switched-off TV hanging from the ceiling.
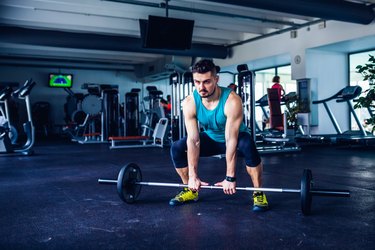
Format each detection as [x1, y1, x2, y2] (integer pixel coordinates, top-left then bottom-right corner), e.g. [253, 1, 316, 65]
[139, 16, 194, 50]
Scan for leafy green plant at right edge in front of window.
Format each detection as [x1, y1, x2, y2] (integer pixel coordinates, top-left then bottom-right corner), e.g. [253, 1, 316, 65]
[354, 55, 375, 133]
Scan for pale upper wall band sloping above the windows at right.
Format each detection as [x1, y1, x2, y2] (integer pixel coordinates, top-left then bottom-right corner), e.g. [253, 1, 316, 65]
[219, 21, 375, 71]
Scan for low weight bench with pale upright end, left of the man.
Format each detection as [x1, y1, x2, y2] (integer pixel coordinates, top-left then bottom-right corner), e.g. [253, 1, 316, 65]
[108, 118, 168, 149]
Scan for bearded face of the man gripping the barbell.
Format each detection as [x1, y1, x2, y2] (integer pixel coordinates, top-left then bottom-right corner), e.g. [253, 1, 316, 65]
[193, 72, 219, 98]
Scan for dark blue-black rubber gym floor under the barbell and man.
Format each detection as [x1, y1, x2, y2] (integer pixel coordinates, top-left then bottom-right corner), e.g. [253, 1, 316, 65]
[0, 140, 375, 249]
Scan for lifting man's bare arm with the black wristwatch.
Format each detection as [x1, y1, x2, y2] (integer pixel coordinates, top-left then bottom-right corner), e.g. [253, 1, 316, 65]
[222, 92, 243, 194]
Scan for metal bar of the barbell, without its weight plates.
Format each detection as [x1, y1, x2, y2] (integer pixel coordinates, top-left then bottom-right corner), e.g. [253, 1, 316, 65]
[98, 179, 350, 197]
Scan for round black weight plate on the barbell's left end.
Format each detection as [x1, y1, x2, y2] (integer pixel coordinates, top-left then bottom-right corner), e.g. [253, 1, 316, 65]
[117, 163, 142, 204]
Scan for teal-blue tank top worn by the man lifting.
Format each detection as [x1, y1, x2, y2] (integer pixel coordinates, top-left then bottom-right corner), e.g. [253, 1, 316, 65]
[193, 87, 249, 142]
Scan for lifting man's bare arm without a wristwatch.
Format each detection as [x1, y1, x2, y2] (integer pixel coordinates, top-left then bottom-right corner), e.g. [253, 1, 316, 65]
[183, 96, 208, 191]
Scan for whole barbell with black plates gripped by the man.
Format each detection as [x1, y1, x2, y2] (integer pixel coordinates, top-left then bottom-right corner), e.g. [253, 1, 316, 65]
[98, 163, 350, 215]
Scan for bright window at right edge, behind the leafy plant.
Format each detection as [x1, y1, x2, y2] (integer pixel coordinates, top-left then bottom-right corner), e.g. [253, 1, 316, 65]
[349, 50, 375, 131]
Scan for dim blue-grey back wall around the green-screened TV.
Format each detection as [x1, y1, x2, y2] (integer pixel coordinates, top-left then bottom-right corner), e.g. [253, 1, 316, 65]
[0, 66, 142, 132]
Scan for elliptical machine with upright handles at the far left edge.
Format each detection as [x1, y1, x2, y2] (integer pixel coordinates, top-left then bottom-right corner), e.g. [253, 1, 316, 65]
[0, 79, 36, 155]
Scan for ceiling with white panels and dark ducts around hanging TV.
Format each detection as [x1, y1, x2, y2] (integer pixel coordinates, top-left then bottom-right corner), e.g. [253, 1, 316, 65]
[0, 0, 375, 71]
